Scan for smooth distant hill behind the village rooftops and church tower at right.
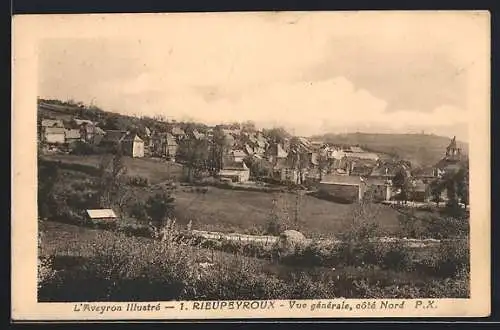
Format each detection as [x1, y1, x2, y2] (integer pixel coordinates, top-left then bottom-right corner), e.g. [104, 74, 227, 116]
[311, 133, 468, 166]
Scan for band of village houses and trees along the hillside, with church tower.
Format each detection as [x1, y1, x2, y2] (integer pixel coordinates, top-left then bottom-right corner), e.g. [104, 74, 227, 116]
[38, 100, 467, 203]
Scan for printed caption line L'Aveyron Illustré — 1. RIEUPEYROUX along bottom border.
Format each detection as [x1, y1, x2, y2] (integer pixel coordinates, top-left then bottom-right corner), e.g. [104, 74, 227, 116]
[73, 299, 437, 314]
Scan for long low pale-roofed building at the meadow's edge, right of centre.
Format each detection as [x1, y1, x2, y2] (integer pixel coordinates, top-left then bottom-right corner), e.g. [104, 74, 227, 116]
[318, 175, 367, 203]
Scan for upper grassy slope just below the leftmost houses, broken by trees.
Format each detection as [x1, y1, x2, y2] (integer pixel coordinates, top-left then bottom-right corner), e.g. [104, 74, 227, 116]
[43, 155, 182, 184]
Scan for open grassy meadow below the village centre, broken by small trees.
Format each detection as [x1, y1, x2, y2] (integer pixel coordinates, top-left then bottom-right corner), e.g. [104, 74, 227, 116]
[176, 187, 399, 237]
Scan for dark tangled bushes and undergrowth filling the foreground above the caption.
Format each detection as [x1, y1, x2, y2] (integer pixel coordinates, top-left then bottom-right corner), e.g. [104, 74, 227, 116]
[39, 225, 469, 301]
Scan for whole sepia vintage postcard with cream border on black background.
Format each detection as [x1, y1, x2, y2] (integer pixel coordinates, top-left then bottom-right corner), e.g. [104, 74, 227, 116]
[11, 11, 490, 321]
